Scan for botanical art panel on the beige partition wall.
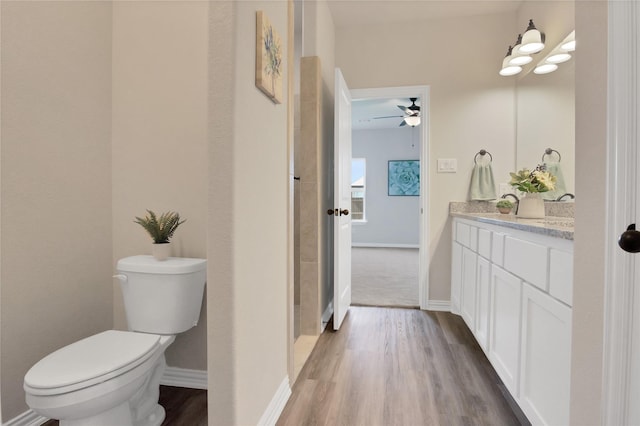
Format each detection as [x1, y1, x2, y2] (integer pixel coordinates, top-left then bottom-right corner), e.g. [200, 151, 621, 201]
[256, 10, 283, 104]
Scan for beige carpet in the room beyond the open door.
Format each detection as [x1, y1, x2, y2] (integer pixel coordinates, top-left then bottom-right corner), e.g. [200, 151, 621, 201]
[351, 247, 420, 307]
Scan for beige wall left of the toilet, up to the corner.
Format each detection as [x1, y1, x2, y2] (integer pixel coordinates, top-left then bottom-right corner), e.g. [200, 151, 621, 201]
[0, 1, 113, 422]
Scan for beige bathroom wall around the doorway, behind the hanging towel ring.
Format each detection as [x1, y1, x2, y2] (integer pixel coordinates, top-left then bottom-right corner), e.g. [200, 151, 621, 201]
[336, 11, 517, 300]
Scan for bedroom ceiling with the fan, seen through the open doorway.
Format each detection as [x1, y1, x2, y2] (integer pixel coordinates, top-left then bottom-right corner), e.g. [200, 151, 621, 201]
[351, 98, 422, 130]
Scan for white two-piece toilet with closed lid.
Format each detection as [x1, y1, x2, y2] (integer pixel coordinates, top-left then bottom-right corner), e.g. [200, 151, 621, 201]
[24, 256, 207, 426]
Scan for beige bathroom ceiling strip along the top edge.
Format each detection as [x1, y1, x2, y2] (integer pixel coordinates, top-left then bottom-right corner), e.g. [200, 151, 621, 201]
[327, 0, 522, 29]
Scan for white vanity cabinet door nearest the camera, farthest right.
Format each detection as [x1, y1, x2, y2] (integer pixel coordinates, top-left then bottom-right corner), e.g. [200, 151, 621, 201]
[520, 283, 571, 425]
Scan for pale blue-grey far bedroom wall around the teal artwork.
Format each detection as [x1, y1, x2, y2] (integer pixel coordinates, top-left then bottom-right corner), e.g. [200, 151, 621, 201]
[352, 126, 420, 247]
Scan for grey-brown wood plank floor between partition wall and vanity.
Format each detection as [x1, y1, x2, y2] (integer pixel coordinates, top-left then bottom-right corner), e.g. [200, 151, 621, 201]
[277, 307, 527, 426]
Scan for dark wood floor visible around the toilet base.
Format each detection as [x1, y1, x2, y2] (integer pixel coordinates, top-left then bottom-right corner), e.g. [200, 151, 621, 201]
[44, 386, 207, 426]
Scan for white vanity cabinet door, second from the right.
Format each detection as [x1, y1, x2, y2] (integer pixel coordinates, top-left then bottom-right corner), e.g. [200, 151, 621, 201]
[489, 265, 522, 399]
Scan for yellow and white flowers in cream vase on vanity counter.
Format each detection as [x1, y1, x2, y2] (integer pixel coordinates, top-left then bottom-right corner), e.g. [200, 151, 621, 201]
[509, 164, 556, 219]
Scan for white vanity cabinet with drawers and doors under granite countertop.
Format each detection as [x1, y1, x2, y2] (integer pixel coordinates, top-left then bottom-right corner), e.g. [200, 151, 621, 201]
[451, 217, 573, 425]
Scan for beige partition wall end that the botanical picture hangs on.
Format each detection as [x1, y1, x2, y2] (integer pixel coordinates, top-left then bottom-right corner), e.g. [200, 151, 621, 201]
[207, 1, 290, 425]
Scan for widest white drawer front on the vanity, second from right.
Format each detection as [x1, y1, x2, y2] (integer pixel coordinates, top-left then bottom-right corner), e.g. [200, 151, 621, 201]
[504, 237, 549, 291]
